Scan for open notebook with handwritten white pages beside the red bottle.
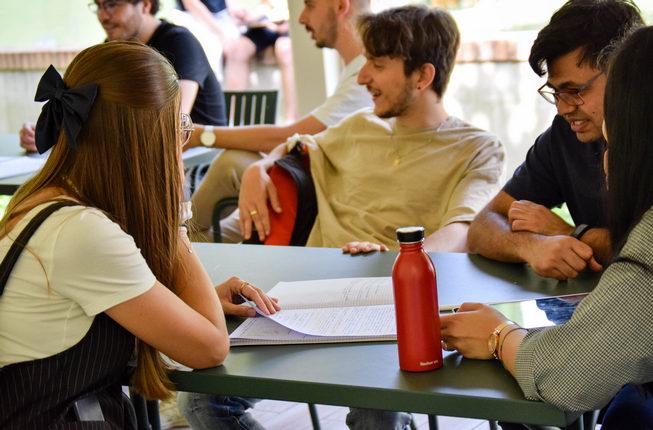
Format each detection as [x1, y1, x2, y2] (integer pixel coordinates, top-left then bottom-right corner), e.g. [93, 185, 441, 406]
[230, 277, 454, 346]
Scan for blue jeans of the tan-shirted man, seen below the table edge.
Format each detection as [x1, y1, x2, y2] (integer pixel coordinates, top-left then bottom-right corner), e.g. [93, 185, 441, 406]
[177, 392, 412, 430]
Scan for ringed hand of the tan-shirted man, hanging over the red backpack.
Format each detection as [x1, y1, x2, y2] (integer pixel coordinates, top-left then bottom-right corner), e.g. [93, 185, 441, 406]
[238, 162, 281, 242]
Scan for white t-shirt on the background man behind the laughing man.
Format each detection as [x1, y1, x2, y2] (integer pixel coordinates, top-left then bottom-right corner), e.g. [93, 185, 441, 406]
[311, 55, 373, 127]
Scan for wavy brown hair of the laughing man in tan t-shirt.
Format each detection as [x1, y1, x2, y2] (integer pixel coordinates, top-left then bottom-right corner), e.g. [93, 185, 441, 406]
[358, 6, 460, 97]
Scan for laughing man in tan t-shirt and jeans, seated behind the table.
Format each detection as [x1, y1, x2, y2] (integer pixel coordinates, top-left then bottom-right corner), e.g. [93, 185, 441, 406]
[183, 6, 504, 430]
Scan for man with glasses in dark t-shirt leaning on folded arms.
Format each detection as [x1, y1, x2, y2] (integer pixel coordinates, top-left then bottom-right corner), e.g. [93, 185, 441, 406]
[468, 0, 644, 280]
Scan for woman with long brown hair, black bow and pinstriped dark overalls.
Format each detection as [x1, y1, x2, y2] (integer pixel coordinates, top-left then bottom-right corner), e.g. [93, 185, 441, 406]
[0, 42, 278, 428]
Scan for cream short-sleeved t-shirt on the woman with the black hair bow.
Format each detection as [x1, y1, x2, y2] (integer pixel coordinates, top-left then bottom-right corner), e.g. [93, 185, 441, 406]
[0, 203, 156, 367]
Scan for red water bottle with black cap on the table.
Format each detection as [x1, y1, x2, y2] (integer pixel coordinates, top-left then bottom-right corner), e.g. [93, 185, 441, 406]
[392, 227, 442, 372]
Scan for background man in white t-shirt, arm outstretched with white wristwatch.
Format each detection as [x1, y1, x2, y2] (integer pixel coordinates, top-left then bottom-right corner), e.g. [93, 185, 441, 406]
[189, 0, 372, 243]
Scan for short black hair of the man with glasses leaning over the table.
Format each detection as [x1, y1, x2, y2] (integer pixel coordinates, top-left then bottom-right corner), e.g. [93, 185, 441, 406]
[528, 0, 644, 76]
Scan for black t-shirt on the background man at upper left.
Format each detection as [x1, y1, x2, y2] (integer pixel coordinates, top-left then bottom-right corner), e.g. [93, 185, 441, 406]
[147, 21, 227, 125]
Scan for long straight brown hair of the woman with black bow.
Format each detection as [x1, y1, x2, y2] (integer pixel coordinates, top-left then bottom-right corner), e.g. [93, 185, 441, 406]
[0, 42, 182, 399]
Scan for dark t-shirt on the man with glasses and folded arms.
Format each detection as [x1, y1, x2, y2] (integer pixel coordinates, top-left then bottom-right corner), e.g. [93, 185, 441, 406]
[503, 115, 606, 227]
